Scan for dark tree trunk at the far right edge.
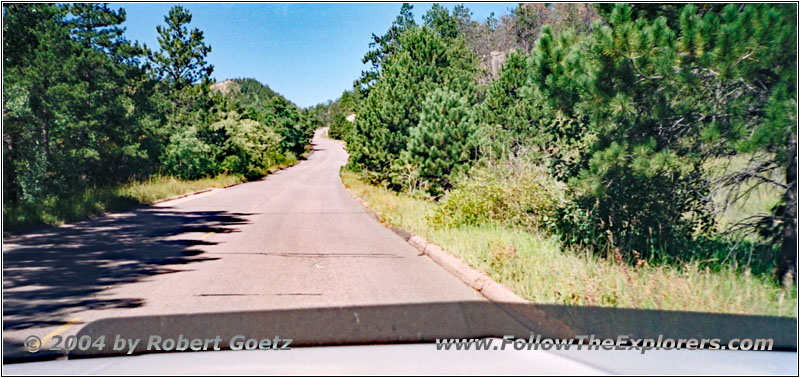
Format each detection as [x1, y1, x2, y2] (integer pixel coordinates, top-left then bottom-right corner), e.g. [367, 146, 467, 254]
[777, 133, 797, 282]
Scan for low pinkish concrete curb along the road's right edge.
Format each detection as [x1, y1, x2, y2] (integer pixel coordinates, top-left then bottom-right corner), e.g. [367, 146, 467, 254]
[348, 190, 530, 303]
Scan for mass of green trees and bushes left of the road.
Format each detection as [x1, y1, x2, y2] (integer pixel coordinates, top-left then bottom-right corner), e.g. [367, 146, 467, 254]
[3, 4, 318, 224]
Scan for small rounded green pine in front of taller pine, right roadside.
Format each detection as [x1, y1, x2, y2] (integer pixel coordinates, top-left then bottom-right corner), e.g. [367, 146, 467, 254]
[401, 89, 478, 195]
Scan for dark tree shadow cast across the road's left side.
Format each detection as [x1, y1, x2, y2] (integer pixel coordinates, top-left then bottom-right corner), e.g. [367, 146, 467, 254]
[3, 207, 249, 330]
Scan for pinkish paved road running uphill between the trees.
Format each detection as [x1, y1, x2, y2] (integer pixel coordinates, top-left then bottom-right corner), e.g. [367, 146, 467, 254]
[3, 131, 483, 350]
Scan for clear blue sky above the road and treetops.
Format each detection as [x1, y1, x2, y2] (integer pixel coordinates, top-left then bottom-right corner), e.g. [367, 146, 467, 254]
[112, 3, 515, 107]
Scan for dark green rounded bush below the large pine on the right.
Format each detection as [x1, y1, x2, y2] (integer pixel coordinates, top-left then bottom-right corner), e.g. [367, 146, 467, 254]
[557, 142, 712, 257]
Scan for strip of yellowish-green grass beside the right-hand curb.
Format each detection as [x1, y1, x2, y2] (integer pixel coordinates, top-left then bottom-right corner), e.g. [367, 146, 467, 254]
[342, 172, 797, 317]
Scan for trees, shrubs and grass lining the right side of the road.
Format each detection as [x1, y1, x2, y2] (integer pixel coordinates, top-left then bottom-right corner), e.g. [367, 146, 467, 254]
[312, 4, 797, 316]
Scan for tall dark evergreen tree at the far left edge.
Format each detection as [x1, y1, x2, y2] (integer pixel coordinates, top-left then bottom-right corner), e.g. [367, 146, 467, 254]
[3, 4, 68, 202]
